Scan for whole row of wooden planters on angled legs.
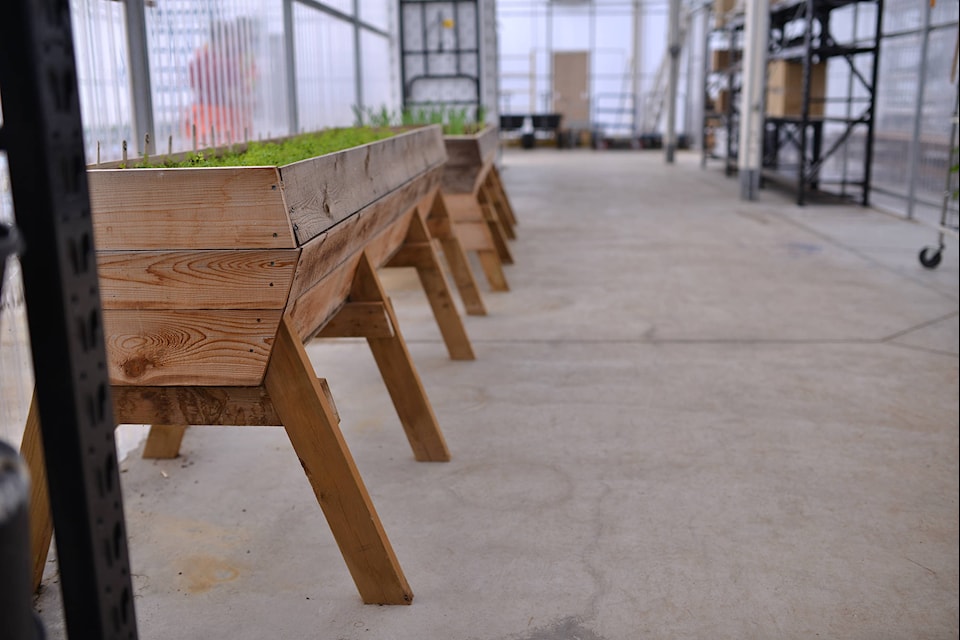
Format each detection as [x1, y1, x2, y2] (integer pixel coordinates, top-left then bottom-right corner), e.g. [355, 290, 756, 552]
[23, 125, 516, 604]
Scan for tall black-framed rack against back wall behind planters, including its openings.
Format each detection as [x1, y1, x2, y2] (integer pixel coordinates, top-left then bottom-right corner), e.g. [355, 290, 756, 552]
[400, 0, 483, 114]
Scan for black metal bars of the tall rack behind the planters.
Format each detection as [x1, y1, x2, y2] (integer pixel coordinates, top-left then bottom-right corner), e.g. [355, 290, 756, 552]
[398, 0, 483, 108]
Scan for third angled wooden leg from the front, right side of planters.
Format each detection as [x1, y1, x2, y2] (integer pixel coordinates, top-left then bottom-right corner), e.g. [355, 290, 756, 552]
[387, 210, 475, 360]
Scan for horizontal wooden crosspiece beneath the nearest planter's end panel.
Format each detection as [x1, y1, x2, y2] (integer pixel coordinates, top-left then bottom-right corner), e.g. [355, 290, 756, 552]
[112, 386, 281, 427]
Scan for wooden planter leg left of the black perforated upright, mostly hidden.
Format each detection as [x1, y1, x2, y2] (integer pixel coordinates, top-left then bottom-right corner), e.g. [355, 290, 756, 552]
[20, 391, 53, 591]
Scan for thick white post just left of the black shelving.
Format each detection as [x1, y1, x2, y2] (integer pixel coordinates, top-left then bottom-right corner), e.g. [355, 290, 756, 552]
[737, 0, 770, 200]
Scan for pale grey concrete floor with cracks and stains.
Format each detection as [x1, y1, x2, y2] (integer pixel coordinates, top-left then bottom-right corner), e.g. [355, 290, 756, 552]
[37, 149, 960, 640]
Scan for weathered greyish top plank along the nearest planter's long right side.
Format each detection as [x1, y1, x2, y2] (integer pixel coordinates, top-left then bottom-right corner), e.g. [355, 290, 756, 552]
[280, 125, 446, 245]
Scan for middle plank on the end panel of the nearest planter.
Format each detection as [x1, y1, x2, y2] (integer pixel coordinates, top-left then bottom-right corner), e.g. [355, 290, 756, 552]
[97, 249, 300, 309]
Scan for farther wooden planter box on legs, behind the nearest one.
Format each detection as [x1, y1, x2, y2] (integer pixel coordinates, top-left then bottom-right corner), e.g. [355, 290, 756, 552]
[441, 126, 516, 292]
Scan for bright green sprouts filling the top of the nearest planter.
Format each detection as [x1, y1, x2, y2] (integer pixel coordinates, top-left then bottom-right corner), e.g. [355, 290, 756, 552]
[129, 127, 397, 169]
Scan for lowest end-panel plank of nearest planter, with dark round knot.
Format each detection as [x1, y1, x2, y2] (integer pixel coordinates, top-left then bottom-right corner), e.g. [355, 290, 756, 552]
[103, 309, 281, 386]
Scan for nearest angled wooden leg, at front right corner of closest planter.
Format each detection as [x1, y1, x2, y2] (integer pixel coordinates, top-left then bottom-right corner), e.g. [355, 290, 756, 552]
[264, 320, 413, 604]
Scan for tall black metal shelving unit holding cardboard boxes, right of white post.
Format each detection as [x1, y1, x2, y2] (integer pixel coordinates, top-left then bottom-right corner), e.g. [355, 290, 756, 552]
[763, 0, 883, 206]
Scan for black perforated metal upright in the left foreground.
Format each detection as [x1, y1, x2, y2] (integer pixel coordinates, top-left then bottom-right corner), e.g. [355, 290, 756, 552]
[0, 0, 137, 639]
